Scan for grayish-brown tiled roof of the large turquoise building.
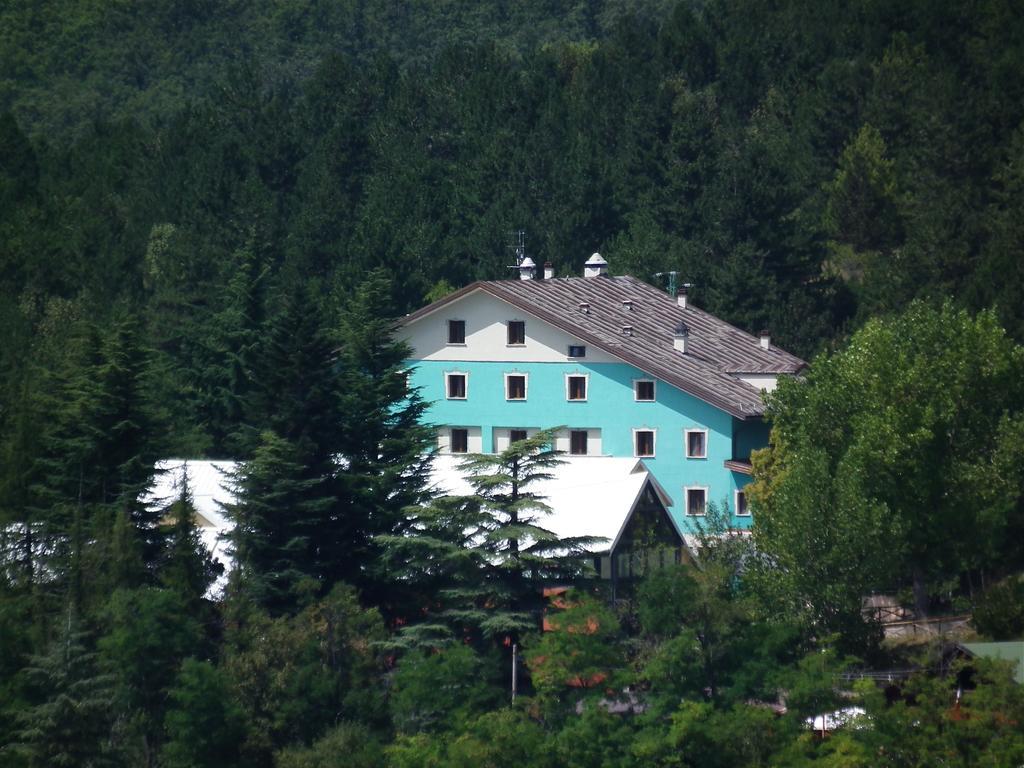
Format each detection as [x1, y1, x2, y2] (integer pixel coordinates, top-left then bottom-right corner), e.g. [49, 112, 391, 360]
[403, 275, 806, 419]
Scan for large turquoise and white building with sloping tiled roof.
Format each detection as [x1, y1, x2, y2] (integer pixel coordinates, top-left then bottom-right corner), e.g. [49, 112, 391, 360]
[400, 264, 799, 532]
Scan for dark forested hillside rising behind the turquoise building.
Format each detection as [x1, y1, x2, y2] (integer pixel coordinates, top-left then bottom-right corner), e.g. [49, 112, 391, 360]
[0, 2, 1024, 438]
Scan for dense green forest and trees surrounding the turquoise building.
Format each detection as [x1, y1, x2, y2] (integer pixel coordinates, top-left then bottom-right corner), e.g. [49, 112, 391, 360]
[0, 0, 1024, 768]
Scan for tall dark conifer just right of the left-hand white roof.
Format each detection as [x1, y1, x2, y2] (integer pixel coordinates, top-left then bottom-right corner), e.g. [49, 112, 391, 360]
[227, 286, 353, 613]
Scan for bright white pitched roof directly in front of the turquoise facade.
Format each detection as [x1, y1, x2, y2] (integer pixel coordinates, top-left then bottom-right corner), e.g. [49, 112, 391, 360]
[431, 454, 681, 551]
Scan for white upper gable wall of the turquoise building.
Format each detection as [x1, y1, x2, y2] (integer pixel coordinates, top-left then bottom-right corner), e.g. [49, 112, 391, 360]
[397, 291, 621, 362]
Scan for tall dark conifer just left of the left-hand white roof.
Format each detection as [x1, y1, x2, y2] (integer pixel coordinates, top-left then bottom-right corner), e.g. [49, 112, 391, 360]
[31, 317, 163, 606]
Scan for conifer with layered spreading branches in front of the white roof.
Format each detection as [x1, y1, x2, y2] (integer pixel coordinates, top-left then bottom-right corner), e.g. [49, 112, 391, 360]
[384, 429, 595, 644]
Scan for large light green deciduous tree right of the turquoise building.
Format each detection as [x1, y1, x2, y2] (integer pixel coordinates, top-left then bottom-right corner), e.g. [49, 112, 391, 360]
[750, 303, 1024, 637]
